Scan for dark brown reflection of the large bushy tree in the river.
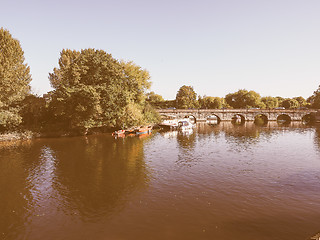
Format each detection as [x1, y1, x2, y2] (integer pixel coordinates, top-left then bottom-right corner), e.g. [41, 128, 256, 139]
[47, 136, 148, 220]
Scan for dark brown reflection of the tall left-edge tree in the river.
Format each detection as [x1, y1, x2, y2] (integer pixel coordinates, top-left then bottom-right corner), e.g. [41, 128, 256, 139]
[0, 141, 41, 239]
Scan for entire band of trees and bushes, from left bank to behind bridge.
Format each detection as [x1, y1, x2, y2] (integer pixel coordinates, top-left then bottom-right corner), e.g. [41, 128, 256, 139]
[0, 28, 320, 140]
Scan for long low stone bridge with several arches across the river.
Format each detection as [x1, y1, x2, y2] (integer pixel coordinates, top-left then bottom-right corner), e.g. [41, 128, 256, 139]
[158, 109, 317, 122]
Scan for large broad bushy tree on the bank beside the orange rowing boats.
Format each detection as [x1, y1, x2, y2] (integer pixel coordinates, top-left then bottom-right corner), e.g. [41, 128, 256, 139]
[49, 49, 157, 130]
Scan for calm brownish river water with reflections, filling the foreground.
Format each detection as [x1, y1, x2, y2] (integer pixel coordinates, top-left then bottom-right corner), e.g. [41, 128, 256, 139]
[0, 123, 320, 240]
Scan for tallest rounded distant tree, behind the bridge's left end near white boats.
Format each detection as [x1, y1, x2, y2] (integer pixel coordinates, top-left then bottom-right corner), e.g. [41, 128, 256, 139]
[176, 85, 198, 109]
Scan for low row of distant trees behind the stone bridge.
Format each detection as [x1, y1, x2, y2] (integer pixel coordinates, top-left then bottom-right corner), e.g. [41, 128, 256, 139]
[147, 85, 320, 109]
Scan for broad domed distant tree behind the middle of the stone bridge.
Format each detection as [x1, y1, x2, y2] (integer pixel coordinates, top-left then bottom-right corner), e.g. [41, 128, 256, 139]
[225, 89, 264, 108]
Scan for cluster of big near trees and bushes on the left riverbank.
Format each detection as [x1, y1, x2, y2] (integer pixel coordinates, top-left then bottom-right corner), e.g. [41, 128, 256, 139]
[0, 28, 159, 133]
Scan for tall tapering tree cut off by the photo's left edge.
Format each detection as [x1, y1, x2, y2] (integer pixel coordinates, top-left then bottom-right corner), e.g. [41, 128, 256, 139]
[0, 28, 31, 130]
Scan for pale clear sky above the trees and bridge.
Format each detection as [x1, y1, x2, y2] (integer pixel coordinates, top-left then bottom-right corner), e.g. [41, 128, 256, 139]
[0, 0, 320, 99]
